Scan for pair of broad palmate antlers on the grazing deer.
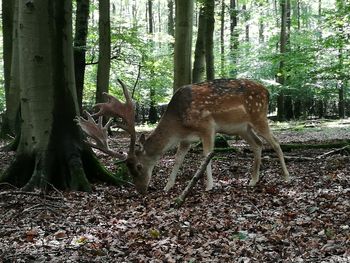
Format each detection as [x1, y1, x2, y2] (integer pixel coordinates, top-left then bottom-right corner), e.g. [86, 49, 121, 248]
[76, 79, 136, 159]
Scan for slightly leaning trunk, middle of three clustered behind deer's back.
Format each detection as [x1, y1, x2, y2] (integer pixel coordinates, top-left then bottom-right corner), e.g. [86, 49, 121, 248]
[192, 6, 206, 83]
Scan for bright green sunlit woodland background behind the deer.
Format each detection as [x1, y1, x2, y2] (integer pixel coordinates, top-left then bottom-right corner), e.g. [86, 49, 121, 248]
[0, 0, 350, 126]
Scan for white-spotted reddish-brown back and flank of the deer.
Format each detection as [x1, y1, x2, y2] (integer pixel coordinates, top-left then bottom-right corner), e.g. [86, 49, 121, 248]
[164, 79, 268, 130]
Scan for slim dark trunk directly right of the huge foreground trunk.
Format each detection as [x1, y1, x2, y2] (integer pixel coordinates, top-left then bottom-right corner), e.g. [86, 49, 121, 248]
[74, 0, 90, 111]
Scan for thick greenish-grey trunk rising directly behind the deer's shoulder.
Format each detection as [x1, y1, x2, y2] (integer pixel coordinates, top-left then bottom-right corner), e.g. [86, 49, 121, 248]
[173, 0, 193, 92]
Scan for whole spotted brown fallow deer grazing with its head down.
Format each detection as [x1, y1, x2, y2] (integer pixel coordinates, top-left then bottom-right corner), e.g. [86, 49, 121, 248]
[76, 79, 290, 194]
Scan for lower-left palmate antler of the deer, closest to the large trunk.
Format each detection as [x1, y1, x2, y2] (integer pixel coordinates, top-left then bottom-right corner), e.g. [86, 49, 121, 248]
[75, 111, 126, 160]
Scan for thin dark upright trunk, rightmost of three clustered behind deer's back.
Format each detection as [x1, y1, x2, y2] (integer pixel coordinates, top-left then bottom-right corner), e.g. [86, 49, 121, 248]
[205, 0, 215, 80]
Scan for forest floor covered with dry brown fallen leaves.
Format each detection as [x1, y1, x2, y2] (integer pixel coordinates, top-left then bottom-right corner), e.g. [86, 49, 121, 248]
[0, 120, 350, 263]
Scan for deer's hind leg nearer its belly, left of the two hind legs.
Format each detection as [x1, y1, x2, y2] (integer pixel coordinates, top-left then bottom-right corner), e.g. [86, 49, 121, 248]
[240, 126, 262, 186]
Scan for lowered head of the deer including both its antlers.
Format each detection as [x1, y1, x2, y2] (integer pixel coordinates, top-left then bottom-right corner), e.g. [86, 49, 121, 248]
[76, 80, 153, 194]
